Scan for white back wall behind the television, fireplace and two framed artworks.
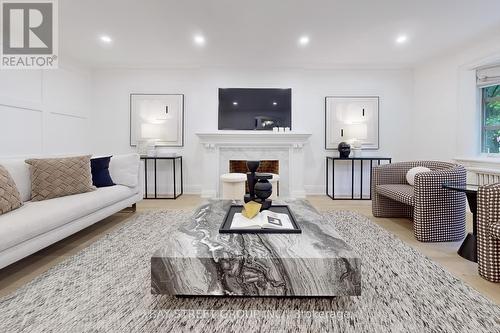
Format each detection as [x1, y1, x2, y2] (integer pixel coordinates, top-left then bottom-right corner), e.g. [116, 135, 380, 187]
[91, 68, 414, 194]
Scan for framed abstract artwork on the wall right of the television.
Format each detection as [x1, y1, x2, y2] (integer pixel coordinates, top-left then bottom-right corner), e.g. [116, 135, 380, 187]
[325, 96, 380, 149]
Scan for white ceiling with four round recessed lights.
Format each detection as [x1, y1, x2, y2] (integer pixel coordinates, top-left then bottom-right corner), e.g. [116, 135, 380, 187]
[59, 0, 500, 68]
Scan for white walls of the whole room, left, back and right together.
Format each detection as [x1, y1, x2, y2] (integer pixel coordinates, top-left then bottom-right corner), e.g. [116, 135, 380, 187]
[0, 31, 500, 194]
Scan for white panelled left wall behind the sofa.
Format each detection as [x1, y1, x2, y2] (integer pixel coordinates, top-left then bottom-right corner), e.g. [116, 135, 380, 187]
[0, 66, 91, 157]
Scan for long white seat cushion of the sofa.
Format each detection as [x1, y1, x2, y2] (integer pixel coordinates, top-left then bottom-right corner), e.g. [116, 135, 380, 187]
[0, 185, 139, 251]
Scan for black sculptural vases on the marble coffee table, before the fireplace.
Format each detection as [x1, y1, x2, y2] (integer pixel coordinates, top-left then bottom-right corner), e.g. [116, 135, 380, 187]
[244, 161, 273, 210]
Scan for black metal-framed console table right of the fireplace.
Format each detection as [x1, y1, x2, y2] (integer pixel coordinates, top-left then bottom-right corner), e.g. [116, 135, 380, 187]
[326, 156, 392, 200]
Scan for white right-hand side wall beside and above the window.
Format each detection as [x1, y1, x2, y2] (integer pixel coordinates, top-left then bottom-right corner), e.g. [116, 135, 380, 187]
[412, 27, 500, 160]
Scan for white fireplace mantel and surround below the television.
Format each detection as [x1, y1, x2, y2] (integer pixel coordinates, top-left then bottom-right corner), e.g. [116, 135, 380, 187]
[196, 131, 311, 198]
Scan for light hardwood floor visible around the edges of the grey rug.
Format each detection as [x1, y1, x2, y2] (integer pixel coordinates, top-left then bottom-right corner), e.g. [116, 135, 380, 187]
[0, 195, 500, 305]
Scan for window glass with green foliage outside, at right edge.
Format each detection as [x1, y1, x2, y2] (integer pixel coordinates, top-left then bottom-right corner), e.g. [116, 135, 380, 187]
[481, 85, 500, 154]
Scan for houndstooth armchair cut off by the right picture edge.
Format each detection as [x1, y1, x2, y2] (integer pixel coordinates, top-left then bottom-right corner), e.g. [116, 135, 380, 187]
[477, 183, 500, 282]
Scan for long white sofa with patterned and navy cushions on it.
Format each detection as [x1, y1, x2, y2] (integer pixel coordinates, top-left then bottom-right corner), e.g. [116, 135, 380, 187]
[0, 154, 143, 268]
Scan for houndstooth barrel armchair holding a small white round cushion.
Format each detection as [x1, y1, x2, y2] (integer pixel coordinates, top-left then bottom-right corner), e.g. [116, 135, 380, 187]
[371, 161, 466, 242]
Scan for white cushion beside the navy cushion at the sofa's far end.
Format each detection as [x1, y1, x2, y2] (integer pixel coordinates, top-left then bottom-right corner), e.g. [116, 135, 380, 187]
[109, 154, 141, 187]
